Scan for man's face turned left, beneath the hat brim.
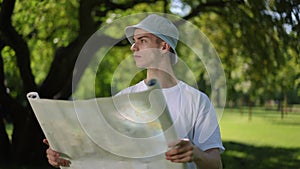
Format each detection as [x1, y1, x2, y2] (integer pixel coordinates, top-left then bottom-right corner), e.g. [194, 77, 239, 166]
[130, 29, 163, 68]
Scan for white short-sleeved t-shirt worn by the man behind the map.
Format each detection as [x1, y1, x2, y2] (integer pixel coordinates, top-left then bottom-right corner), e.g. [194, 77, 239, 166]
[118, 81, 225, 169]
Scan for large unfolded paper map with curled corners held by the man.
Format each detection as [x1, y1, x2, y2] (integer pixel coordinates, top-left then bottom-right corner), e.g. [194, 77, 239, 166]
[27, 81, 186, 169]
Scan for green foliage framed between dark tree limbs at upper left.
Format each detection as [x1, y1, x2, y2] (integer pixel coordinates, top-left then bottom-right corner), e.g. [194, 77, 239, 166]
[12, 0, 79, 84]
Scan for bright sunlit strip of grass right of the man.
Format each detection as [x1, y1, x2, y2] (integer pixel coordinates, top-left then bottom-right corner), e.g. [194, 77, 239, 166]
[220, 109, 300, 148]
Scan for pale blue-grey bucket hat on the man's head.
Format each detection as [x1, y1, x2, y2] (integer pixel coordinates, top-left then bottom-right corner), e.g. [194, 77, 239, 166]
[125, 14, 179, 64]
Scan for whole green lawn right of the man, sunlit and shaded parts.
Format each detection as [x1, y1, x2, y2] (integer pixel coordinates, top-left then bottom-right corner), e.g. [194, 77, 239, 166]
[220, 108, 300, 169]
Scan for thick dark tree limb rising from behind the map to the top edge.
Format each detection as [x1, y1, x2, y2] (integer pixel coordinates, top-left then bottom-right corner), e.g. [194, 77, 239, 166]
[39, 0, 101, 99]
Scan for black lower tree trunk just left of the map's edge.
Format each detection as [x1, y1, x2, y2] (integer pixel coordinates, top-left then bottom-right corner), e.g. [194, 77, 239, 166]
[11, 97, 46, 164]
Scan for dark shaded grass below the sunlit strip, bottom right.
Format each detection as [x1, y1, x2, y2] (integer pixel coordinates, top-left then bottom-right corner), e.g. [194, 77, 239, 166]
[222, 142, 300, 169]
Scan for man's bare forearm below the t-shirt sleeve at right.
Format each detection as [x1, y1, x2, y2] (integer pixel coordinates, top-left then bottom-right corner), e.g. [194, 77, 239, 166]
[193, 148, 223, 169]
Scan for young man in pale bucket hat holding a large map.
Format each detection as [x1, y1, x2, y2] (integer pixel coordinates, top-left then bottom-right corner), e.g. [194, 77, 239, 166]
[44, 14, 224, 169]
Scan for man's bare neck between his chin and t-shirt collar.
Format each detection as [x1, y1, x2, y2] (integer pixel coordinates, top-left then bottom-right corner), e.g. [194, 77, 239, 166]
[145, 68, 178, 88]
